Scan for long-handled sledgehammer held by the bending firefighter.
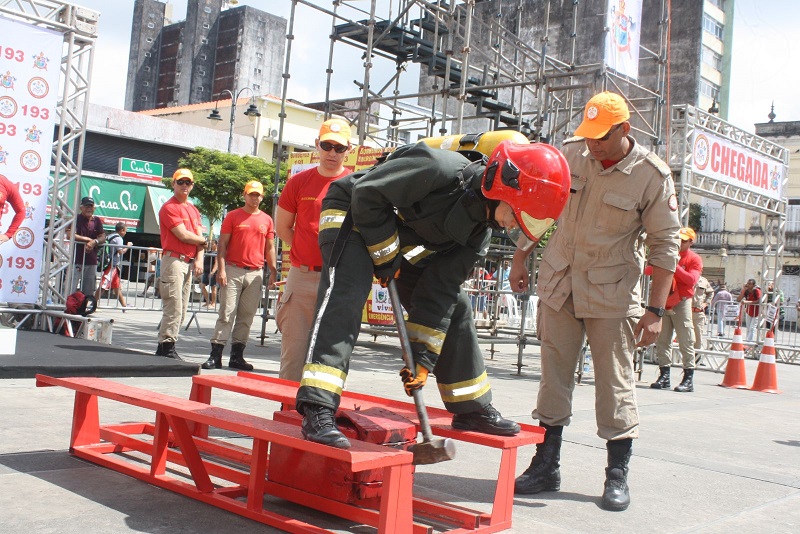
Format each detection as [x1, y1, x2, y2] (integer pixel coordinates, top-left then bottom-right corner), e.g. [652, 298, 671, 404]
[389, 280, 456, 465]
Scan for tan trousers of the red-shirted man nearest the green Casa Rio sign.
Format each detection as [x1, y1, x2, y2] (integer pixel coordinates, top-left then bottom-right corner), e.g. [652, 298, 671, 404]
[158, 256, 194, 343]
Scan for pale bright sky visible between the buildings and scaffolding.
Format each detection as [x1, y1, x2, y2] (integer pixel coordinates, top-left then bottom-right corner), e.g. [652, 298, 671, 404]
[76, 0, 800, 131]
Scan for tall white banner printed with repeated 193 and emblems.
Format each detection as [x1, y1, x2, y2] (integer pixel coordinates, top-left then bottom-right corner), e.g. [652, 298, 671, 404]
[0, 16, 64, 304]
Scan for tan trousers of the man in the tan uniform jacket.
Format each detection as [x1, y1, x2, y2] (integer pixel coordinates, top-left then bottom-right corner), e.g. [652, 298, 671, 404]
[532, 295, 639, 440]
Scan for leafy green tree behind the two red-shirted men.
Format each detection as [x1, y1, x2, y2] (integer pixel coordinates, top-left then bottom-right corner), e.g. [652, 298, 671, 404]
[164, 147, 286, 237]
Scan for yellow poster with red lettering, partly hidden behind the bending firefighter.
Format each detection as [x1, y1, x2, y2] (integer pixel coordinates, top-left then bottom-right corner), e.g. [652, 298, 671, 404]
[281, 146, 394, 325]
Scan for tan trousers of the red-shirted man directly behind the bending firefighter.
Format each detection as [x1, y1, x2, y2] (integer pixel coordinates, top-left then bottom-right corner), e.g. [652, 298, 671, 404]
[275, 266, 320, 382]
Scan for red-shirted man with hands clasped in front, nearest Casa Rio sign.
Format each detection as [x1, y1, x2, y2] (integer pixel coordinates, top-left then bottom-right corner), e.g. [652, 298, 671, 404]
[156, 169, 206, 360]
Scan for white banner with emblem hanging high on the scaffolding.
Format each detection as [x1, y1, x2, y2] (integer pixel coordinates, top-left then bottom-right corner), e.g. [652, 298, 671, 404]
[605, 0, 642, 80]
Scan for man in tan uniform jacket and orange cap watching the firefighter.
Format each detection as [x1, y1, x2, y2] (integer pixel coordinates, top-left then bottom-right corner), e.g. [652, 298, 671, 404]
[509, 92, 680, 511]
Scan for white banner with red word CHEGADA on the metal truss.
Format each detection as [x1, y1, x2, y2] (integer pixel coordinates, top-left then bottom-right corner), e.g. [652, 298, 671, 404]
[692, 130, 787, 200]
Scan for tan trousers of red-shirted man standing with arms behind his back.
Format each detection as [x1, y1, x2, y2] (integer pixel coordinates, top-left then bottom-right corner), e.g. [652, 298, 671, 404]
[211, 264, 264, 345]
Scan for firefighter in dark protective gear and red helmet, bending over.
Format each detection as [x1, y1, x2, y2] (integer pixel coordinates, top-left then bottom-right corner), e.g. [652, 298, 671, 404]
[297, 141, 570, 448]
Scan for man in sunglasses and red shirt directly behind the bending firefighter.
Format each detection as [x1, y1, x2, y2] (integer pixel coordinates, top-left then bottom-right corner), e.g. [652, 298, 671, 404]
[275, 119, 351, 382]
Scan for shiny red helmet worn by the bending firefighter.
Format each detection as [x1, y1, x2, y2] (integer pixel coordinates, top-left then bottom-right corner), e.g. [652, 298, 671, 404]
[481, 141, 570, 244]
